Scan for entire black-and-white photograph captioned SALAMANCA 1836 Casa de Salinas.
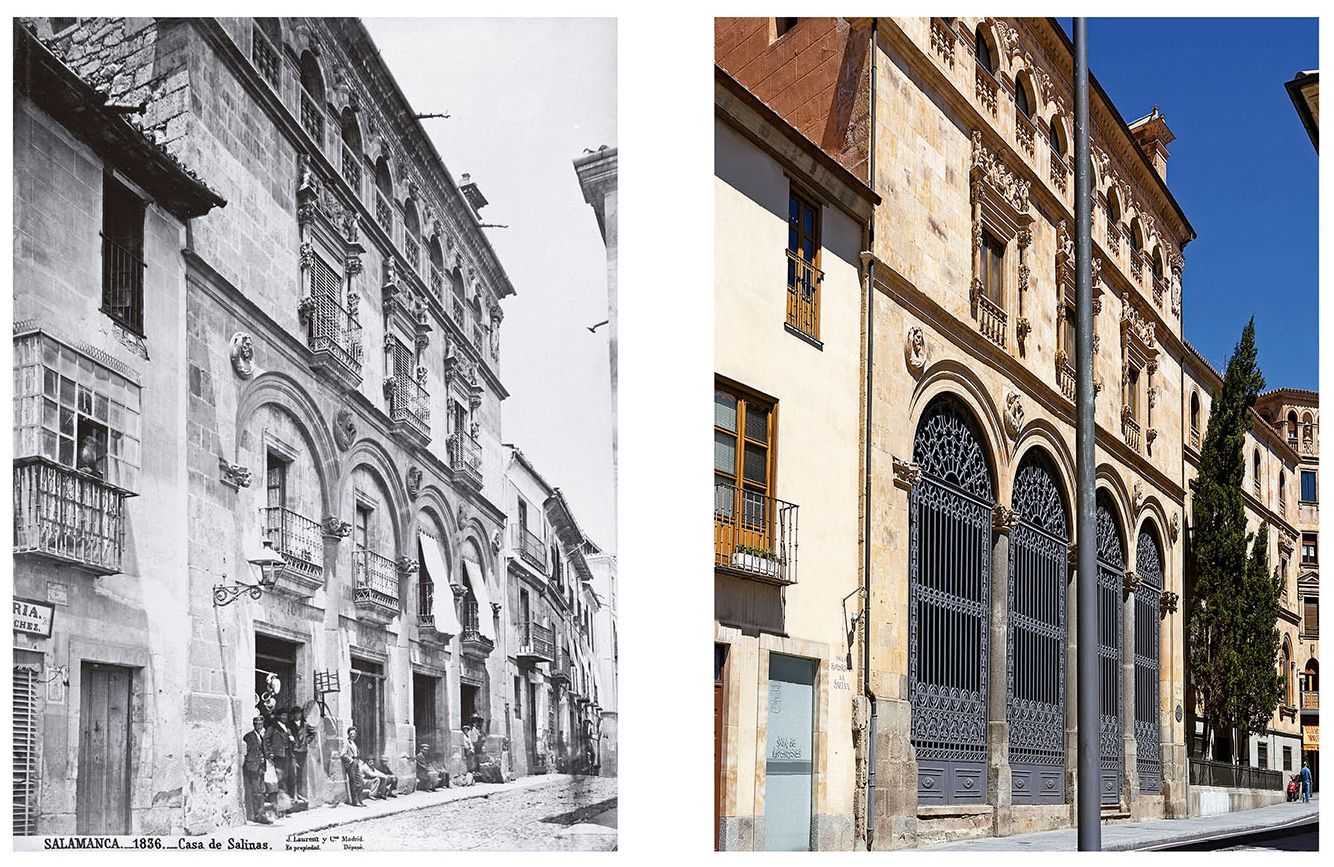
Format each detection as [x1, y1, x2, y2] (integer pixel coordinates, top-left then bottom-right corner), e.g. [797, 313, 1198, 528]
[12, 16, 619, 851]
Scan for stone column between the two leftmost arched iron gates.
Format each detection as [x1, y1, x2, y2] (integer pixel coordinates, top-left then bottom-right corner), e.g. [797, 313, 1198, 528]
[987, 503, 1019, 836]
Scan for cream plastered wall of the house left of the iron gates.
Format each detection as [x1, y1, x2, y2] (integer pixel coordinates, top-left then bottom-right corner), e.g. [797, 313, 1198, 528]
[714, 114, 862, 837]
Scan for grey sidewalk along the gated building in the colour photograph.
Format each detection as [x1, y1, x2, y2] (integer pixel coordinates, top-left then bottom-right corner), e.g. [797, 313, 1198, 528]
[920, 795, 1321, 852]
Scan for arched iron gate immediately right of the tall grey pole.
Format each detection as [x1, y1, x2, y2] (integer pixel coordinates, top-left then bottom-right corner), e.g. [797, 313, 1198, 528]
[1097, 494, 1126, 804]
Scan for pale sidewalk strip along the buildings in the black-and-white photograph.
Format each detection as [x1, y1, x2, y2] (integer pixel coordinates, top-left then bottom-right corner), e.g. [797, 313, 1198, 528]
[197, 774, 580, 848]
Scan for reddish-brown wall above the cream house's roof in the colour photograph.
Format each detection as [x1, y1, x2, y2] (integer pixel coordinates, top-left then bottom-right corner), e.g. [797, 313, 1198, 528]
[714, 17, 870, 180]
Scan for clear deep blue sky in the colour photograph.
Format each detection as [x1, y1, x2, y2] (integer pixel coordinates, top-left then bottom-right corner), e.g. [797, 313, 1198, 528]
[1061, 19, 1319, 389]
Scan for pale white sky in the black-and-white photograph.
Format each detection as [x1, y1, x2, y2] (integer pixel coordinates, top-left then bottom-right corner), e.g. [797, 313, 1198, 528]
[363, 19, 616, 551]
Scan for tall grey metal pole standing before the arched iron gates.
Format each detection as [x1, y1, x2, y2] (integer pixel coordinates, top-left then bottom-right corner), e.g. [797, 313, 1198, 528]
[1074, 17, 1102, 852]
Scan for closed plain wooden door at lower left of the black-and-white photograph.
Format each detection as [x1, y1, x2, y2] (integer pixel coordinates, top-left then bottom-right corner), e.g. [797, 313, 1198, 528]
[76, 663, 131, 834]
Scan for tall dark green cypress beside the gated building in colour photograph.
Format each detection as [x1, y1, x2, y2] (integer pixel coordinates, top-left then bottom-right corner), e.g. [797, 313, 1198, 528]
[1186, 317, 1279, 758]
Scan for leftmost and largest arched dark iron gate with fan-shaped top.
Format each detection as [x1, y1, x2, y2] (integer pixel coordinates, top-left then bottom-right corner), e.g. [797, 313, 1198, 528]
[908, 399, 995, 804]
